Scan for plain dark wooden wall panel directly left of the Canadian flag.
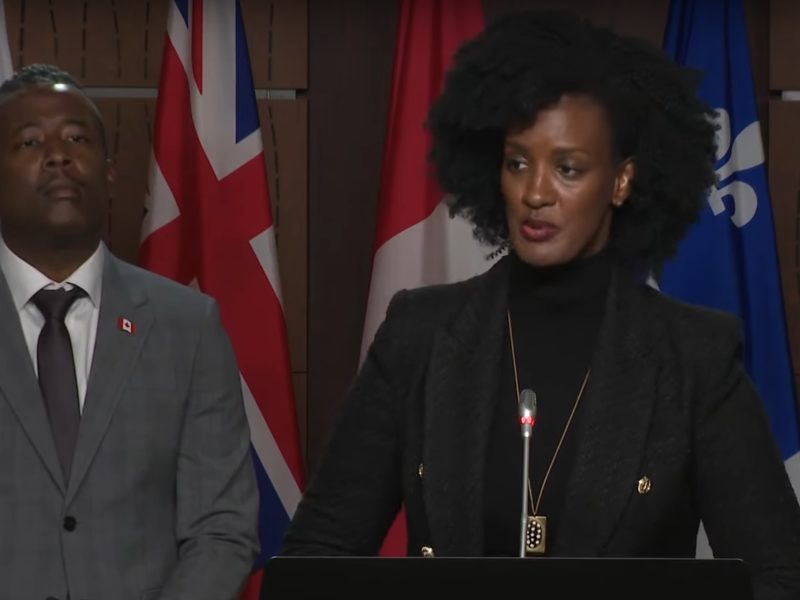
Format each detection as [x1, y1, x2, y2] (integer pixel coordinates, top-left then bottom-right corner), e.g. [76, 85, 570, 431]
[308, 0, 399, 466]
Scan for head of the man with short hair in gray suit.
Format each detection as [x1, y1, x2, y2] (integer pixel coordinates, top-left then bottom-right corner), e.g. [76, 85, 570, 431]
[0, 84, 114, 251]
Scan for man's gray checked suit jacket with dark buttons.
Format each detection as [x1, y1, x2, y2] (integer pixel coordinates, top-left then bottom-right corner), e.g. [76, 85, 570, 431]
[0, 251, 258, 600]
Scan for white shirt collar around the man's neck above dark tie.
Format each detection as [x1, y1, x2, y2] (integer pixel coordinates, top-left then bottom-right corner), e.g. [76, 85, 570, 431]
[0, 236, 105, 311]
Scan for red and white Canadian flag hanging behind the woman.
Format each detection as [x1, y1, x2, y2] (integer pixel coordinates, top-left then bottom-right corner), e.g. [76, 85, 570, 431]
[361, 0, 492, 556]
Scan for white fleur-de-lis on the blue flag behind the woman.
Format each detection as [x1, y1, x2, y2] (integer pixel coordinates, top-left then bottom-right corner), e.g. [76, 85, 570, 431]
[708, 108, 764, 227]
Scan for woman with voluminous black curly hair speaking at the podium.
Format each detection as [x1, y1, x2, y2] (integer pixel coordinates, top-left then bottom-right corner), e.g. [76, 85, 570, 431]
[284, 13, 800, 598]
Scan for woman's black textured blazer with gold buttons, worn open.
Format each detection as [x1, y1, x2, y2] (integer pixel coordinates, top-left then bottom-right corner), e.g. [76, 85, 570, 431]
[283, 259, 800, 599]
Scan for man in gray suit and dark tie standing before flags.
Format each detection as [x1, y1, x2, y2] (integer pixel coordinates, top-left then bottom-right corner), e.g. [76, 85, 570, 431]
[0, 65, 257, 600]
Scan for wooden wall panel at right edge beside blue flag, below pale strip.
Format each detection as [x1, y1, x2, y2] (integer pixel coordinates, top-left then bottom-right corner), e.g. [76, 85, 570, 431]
[769, 100, 800, 398]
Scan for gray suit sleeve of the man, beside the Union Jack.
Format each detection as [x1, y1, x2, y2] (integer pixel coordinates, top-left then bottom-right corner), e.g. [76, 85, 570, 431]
[160, 301, 258, 600]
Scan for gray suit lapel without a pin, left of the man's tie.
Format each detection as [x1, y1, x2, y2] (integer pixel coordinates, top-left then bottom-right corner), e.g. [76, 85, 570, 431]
[0, 273, 66, 494]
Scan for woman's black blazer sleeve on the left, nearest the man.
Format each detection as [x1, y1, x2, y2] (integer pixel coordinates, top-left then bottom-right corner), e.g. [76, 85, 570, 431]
[282, 294, 407, 556]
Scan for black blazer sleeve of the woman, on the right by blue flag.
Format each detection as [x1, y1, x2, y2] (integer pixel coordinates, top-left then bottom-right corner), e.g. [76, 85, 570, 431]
[694, 316, 800, 600]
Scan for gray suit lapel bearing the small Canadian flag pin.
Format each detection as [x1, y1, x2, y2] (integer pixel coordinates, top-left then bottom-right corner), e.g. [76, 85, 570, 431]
[66, 252, 152, 502]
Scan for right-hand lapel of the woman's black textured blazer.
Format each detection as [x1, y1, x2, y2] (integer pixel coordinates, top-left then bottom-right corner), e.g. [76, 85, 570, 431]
[553, 271, 658, 556]
